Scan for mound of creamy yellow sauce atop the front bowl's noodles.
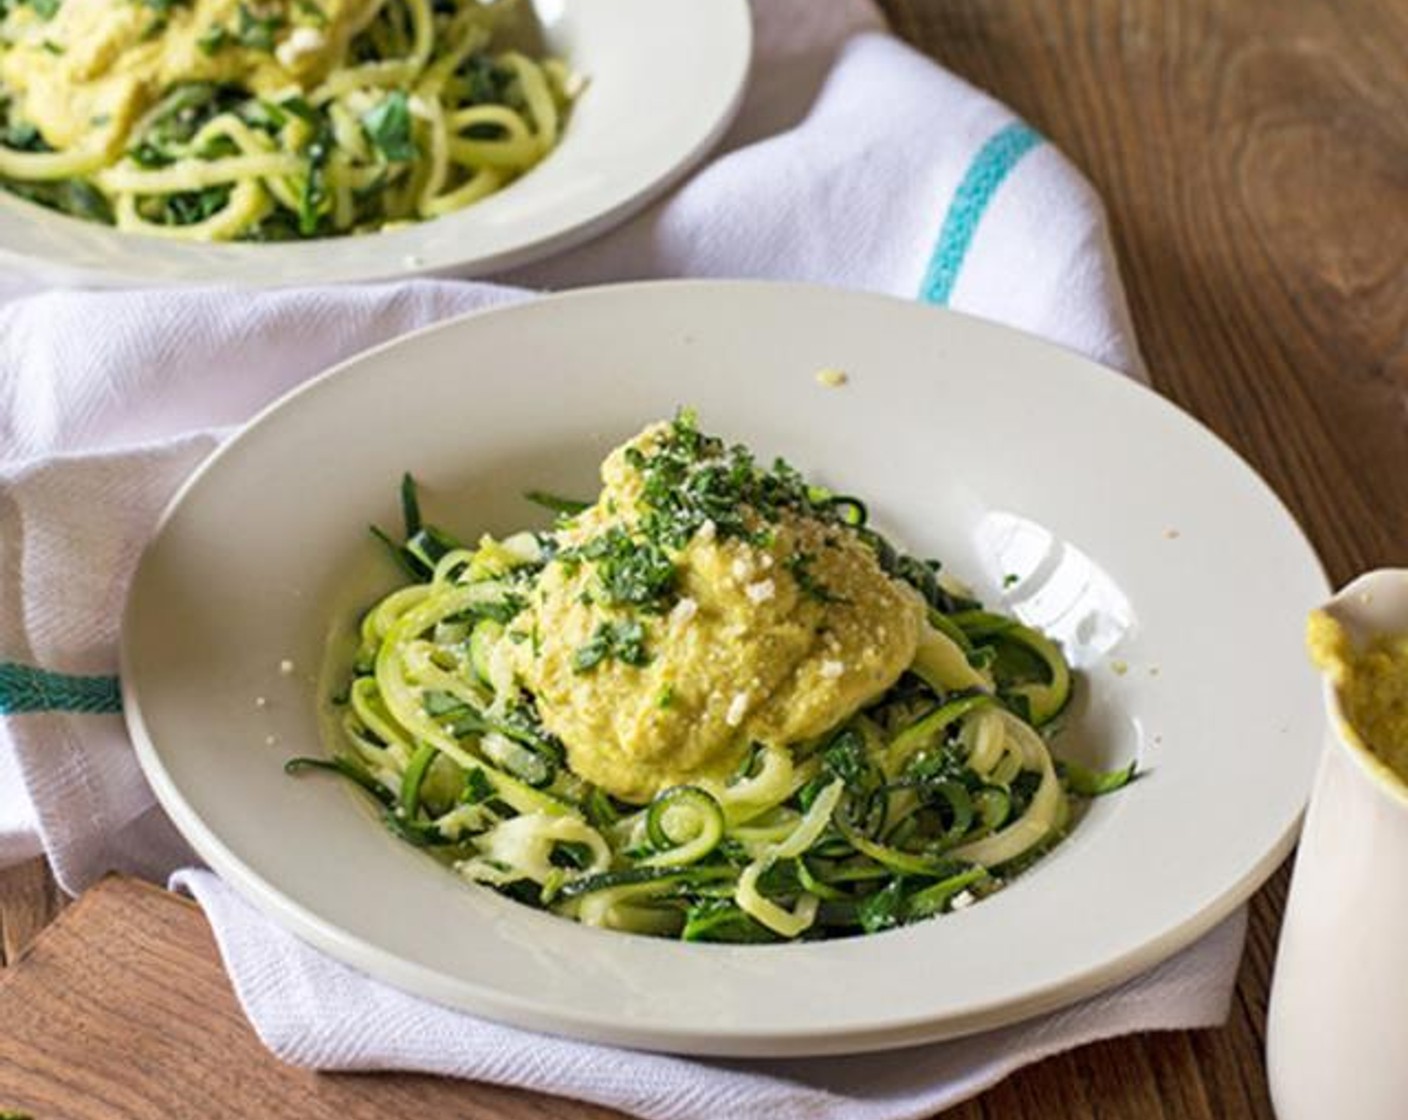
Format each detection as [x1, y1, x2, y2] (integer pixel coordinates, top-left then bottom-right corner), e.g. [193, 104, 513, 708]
[515, 425, 924, 802]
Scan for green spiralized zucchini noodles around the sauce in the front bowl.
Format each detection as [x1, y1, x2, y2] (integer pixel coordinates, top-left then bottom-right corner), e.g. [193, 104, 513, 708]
[290, 420, 1133, 942]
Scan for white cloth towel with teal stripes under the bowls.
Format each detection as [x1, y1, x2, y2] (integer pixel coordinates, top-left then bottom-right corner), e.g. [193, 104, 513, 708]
[0, 0, 1245, 1117]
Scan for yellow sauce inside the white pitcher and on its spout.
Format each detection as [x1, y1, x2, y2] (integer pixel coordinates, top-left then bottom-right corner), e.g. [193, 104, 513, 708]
[1305, 610, 1408, 782]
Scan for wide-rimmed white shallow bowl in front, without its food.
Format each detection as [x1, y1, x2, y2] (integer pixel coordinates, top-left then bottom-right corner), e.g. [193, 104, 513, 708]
[122, 283, 1325, 1055]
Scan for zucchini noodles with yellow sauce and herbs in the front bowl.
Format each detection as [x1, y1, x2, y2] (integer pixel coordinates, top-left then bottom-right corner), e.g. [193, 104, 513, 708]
[287, 410, 1133, 942]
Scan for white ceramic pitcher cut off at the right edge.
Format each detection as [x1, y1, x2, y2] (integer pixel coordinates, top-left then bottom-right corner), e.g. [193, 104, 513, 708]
[1267, 569, 1408, 1120]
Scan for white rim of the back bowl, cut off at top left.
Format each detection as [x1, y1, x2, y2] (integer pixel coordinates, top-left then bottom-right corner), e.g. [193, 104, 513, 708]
[0, 0, 752, 286]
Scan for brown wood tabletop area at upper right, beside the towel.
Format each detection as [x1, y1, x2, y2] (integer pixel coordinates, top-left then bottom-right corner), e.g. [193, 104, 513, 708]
[883, 0, 1408, 583]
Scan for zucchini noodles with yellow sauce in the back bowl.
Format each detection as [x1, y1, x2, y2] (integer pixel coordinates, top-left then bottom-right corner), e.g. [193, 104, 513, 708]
[0, 0, 580, 241]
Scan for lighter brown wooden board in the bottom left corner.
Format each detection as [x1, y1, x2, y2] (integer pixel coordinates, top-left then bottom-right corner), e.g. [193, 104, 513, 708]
[0, 879, 617, 1120]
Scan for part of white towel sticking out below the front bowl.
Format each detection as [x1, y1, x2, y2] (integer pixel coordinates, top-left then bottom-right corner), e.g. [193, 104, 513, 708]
[173, 871, 1245, 1120]
